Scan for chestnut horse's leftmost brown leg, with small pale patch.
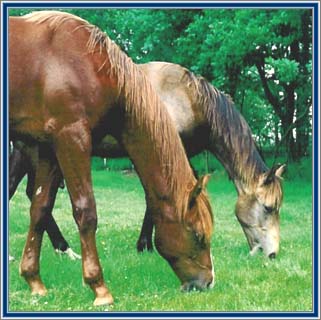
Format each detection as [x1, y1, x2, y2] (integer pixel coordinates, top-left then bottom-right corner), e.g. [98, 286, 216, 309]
[20, 147, 59, 295]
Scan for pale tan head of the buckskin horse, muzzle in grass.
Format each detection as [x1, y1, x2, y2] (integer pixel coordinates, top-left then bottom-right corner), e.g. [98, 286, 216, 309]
[235, 165, 285, 259]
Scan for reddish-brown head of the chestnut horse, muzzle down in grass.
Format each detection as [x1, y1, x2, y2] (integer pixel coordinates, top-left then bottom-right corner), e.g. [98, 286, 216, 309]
[155, 175, 214, 291]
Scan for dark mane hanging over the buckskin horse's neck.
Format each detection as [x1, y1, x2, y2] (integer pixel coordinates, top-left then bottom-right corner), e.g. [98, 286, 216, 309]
[181, 70, 267, 183]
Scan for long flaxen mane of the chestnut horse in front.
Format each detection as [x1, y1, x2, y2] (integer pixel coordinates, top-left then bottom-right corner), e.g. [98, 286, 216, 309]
[25, 11, 212, 233]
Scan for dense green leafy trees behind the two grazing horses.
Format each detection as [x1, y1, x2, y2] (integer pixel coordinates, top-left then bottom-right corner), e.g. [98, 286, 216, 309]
[10, 9, 312, 159]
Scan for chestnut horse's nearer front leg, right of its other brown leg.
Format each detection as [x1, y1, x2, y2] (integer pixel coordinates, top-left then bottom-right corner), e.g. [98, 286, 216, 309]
[55, 120, 113, 305]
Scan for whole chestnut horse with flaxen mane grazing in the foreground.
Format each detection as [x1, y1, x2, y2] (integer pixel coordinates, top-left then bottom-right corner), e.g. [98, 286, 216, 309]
[9, 11, 214, 305]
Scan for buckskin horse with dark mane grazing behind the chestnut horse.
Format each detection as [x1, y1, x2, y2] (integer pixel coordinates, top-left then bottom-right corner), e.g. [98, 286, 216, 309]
[10, 62, 284, 258]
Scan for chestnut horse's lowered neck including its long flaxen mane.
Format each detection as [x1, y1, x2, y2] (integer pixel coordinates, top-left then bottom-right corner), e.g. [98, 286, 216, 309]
[87, 28, 195, 212]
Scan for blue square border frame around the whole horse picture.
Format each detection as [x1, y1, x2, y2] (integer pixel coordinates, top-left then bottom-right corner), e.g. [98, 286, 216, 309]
[1, 1, 320, 319]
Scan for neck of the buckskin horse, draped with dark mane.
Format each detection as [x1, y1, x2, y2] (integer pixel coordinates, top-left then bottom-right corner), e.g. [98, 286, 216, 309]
[203, 84, 267, 194]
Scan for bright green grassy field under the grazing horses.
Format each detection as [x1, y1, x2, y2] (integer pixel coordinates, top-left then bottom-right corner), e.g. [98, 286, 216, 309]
[9, 160, 312, 311]
